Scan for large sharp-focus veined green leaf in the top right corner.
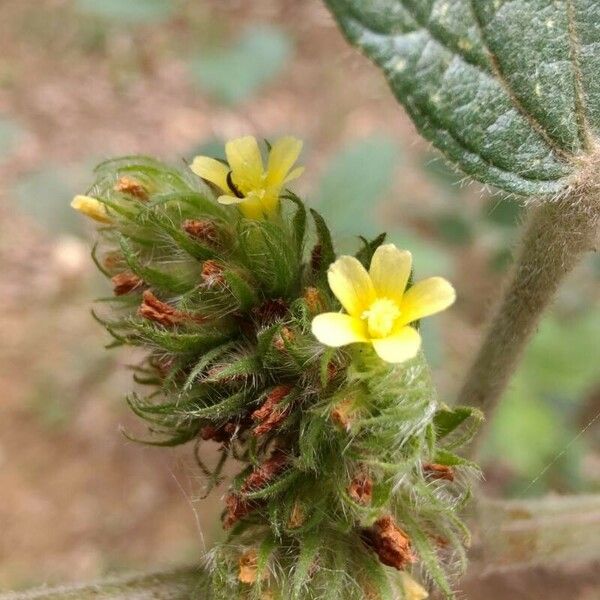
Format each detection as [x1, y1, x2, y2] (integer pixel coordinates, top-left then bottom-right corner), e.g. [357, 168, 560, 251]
[326, 0, 600, 195]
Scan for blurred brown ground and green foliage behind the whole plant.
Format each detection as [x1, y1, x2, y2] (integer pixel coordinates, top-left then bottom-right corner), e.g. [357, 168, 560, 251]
[0, 0, 600, 600]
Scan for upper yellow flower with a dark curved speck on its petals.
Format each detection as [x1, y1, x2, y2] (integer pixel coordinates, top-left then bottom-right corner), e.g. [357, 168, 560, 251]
[191, 135, 304, 219]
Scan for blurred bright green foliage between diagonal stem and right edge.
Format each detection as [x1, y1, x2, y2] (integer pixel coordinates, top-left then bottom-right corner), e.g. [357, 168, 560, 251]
[484, 310, 600, 495]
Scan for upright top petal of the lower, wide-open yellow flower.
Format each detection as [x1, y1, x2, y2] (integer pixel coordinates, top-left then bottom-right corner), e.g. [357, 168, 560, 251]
[369, 244, 412, 302]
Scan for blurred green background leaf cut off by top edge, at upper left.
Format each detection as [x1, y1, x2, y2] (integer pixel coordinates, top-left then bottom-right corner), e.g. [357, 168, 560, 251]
[75, 0, 176, 24]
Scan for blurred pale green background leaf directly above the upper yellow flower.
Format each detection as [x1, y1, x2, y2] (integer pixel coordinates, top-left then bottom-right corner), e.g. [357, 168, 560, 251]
[190, 25, 293, 104]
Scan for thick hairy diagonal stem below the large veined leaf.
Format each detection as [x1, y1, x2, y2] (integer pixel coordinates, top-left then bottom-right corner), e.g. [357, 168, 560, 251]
[459, 162, 600, 436]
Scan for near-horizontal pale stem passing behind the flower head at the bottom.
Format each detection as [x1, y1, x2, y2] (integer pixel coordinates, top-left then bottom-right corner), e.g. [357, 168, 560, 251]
[0, 495, 600, 600]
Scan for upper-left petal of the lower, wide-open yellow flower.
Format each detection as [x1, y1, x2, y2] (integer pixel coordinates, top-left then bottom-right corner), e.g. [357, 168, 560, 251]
[327, 256, 375, 317]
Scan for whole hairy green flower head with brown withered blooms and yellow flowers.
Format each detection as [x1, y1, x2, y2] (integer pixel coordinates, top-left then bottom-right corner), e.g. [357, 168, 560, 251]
[73, 137, 480, 600]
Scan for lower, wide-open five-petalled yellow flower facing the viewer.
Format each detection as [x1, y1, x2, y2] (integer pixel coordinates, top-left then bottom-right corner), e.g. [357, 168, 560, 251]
[312, 244, 456, 363]
